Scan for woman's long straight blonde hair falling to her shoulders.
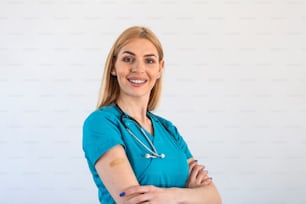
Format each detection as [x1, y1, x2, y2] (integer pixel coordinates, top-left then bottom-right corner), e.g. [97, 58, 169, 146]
[97, 26, 164, 111]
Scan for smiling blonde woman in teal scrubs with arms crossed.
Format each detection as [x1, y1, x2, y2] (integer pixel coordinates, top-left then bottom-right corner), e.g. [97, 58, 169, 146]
[83, 26, 221, 204]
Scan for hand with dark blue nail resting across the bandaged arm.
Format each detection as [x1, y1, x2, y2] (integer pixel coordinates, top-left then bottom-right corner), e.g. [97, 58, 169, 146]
[120, 186, 177, 204]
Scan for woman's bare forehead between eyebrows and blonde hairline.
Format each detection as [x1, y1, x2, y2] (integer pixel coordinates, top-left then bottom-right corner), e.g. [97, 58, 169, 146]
[119, 38, 158, 55]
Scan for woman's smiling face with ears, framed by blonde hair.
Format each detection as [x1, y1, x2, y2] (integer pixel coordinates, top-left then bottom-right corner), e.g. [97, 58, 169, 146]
[111, 38, 164, 103]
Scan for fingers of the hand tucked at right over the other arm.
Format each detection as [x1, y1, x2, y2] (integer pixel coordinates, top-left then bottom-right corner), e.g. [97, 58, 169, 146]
[186, 160, 212, 188]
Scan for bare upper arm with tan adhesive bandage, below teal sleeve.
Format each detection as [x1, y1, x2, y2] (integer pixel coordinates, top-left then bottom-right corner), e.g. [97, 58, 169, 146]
[95, 145, 139, 203]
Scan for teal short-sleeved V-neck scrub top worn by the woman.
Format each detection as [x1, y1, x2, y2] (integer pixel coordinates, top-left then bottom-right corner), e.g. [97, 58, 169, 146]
[83, 105, 192, 204]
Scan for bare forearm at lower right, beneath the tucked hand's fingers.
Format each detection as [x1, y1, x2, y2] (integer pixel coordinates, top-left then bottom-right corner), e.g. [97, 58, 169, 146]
[173, 183, 221, 204]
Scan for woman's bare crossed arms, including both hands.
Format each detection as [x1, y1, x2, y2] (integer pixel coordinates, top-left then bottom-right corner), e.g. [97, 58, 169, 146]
[95, 145, 221, 204]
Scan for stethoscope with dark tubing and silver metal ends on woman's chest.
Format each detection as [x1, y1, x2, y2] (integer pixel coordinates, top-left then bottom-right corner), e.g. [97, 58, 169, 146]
[116, 104, 166, 159]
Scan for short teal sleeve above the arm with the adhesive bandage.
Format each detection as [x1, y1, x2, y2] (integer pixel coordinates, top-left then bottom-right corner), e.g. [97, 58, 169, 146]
[83, 111, 124, 165]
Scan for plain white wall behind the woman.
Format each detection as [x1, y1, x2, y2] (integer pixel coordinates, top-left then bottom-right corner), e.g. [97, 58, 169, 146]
[0, 0, 306, 204]
